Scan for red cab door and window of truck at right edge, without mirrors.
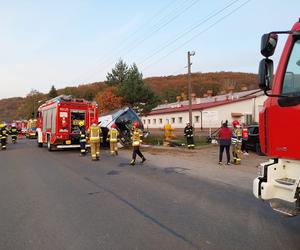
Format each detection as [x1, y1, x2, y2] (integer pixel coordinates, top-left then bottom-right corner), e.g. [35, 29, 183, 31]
[261, 23, 300, 160]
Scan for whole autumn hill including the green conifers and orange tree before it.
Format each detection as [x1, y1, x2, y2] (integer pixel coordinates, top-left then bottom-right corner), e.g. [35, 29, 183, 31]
[0, 60, 258, 121]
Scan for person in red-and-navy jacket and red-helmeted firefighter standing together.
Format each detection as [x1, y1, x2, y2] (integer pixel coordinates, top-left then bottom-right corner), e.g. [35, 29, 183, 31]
[219, 120, 248, 165]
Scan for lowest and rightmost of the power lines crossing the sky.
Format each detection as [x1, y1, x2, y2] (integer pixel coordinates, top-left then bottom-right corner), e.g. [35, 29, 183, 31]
[142, 0, 251, 71]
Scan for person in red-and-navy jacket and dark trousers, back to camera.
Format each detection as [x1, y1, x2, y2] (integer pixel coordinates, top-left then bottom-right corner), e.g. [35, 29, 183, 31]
[219, 122, 232, 165]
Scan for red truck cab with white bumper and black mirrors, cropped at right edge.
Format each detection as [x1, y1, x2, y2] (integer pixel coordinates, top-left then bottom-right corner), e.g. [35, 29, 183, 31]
[253, 20, 300, 216]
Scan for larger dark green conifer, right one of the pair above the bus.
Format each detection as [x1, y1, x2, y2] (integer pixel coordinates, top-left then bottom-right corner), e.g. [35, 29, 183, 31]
[118, 64, 159, 114]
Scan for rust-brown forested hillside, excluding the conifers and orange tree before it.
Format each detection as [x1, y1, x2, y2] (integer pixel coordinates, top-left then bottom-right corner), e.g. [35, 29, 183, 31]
[0, 72, 258, 121]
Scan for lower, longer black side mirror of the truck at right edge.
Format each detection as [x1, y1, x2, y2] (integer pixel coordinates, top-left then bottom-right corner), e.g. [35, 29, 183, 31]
[258, 58, 273, 91]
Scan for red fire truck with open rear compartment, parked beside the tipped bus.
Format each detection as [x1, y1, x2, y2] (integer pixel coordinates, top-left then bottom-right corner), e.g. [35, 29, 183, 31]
[36, 95, 98, 151]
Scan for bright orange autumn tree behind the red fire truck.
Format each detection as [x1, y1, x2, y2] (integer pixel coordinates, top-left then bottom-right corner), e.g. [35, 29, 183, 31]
[95, 87, 123, 113]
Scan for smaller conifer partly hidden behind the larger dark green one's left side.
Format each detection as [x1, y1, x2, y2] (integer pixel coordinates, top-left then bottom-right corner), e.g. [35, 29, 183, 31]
[106, 59, 128, 85]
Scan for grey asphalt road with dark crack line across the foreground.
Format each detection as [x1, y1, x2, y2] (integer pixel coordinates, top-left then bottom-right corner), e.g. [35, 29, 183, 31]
[0, 140, 300, 250]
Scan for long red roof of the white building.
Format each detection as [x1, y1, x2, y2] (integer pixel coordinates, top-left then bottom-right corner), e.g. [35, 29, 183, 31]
[147, 93, 263, 116]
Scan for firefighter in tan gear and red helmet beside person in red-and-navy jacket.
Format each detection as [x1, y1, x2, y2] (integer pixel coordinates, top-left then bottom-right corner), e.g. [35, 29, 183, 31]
[231, 120, 242, 165]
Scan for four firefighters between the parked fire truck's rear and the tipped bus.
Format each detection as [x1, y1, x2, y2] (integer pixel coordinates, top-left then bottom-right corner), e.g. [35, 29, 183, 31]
[79, 120, 146, 166]
